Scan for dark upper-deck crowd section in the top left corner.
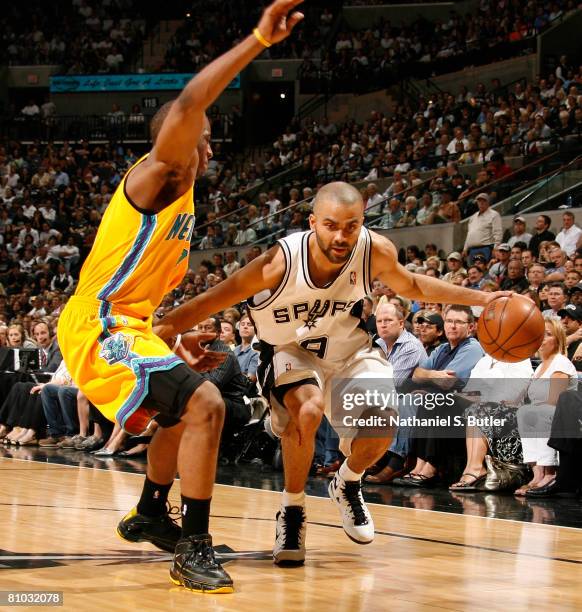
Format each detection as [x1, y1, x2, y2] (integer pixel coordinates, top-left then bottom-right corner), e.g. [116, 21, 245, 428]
[0, 0, 145, 74]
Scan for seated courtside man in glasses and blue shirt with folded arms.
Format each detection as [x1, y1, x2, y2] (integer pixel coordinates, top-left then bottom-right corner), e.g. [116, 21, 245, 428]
[394, 305, 485, 487]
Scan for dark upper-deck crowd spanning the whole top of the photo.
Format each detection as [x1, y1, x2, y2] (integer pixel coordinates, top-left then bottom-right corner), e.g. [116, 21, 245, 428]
[0, 0, 579, 83]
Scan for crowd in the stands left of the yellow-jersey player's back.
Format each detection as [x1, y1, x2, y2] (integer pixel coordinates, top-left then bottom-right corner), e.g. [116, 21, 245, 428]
[0, 142, 143, 333]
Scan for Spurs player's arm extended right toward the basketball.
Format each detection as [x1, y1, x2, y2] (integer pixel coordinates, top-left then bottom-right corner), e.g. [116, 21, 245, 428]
[370, 232, 511, 306]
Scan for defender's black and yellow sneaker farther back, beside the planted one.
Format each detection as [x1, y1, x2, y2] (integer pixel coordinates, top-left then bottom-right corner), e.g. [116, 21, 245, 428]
[117, 504, 182, 553]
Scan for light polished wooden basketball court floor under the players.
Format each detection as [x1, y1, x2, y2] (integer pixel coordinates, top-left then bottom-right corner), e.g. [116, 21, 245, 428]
[0, 458, 582, 612]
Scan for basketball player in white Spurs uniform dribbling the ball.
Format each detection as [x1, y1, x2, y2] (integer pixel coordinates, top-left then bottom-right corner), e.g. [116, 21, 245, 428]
[160, 182, 510, 565]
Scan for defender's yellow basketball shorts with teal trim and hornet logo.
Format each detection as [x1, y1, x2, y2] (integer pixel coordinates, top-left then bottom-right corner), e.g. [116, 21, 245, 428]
[57, 296, 205, 434]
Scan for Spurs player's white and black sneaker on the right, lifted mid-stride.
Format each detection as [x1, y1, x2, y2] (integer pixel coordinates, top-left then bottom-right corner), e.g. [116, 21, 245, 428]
[327, 472, 374, 544]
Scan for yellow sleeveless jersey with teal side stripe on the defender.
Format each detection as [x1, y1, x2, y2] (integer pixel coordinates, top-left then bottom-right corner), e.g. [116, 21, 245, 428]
[75, 157, 194, 318]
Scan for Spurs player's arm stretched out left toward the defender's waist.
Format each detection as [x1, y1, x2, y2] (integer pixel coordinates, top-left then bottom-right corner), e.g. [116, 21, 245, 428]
[154, 246, 285, 340]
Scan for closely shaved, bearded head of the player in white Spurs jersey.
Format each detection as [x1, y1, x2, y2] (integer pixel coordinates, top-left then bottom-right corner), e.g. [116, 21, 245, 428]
[309, 182, 364, 264]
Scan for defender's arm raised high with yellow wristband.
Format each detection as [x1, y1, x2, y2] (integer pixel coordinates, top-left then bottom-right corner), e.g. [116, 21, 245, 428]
[127, 0, 303, 210]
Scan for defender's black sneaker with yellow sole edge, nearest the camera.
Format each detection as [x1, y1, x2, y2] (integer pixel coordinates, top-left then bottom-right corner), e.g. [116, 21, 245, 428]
[170, 533, 234, 593]
